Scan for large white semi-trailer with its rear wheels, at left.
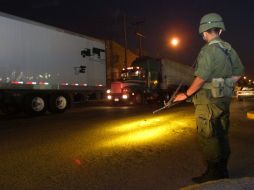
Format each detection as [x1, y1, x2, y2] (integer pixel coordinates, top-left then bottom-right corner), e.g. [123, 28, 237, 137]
[0, 13, 106, 115]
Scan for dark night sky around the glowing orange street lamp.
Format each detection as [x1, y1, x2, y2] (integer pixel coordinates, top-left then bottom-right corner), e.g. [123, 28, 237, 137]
[0, 0, 254, 80]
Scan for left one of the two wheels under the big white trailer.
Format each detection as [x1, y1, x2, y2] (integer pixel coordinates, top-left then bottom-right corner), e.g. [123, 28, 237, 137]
[24, 95, 47, 116]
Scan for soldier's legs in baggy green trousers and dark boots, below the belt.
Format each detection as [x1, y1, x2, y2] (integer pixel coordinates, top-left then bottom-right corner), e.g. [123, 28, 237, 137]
[193, 105, 228, 183]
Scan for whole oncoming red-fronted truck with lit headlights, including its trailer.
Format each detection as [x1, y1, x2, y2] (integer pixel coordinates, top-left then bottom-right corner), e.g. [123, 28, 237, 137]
[107, 57, 194, 104]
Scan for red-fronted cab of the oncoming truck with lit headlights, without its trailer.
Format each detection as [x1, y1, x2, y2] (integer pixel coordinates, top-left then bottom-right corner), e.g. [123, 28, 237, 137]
[107, 57, 160, 104]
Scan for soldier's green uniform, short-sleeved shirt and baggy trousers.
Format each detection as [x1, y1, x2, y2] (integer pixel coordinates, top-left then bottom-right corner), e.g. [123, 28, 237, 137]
[193, 37, 244, 181]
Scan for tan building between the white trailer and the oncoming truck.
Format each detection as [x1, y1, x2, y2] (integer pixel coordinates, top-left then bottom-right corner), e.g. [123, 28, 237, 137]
[106, 40, 138, 85]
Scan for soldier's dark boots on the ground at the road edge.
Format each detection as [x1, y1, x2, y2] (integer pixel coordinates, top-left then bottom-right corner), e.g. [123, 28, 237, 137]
[192, 162, 225, 183]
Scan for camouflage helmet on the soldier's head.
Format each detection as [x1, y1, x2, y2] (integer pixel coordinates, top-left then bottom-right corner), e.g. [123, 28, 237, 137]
[199, 13, 226, 34]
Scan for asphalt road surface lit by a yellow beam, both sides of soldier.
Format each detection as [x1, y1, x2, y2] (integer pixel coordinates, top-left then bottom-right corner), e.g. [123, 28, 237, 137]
[0, 102, 254, 190]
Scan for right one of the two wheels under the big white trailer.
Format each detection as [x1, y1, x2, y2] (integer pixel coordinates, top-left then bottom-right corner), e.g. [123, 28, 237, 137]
[49, 94, 69, 113]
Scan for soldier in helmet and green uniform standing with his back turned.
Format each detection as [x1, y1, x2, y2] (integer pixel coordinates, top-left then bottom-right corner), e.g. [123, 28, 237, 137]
[174, 13, 244, 183]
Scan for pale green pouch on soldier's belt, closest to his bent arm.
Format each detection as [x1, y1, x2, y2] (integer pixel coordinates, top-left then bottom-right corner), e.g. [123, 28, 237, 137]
[211, 78, 225, 98]
